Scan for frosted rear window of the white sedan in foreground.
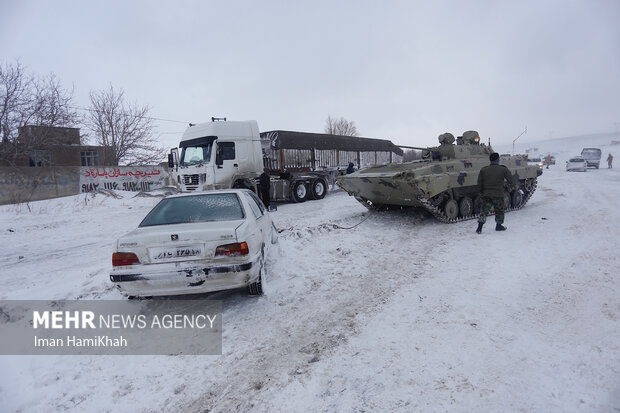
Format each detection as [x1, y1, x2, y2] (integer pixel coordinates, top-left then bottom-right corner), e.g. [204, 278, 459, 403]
[140, 194, 244, 227]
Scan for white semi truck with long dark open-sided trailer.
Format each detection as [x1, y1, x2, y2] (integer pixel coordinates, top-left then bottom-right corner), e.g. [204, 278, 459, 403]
[168, 118, 403, 202]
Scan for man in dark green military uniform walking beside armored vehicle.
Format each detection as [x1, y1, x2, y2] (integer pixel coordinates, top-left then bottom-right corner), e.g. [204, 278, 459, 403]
[476, 152, 515, 234]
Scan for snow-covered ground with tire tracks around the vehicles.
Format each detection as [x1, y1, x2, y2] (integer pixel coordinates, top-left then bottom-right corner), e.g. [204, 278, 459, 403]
[0, 136, 620, 412]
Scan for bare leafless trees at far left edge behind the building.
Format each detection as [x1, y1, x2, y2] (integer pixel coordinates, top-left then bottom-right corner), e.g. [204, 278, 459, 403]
[0, 61, 80, 165]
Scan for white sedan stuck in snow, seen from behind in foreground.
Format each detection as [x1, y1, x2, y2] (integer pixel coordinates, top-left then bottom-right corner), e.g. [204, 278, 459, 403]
[110, 189, 277, 297]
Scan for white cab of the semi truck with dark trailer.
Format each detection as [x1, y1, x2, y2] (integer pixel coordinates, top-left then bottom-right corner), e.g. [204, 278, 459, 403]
[168, 119, 263, 192]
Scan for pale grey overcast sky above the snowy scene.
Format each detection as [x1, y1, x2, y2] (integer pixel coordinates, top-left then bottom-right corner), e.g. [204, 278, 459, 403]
[0, 0, 620, 147]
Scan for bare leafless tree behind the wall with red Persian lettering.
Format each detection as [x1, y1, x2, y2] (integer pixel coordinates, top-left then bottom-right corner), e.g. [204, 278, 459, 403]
[86, 85, 165, 165]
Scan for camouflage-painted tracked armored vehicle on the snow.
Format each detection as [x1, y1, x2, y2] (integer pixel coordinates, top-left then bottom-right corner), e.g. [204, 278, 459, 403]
[336, 131, 542, 223]
